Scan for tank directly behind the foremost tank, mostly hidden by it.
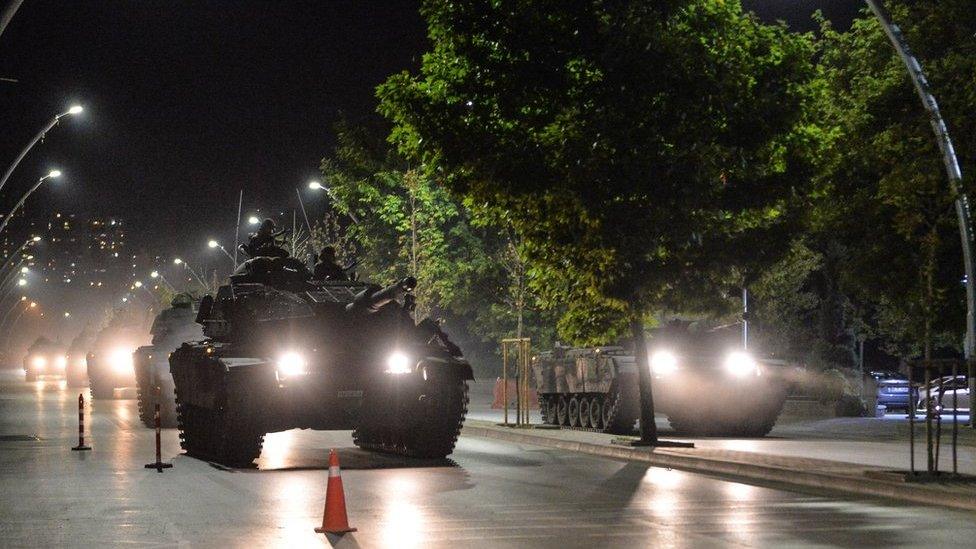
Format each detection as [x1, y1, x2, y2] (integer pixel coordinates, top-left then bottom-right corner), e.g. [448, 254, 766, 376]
[132, 293, 203, 427]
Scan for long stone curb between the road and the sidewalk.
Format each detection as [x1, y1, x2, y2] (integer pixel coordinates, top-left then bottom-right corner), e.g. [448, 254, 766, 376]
[461, 424, 976, 511]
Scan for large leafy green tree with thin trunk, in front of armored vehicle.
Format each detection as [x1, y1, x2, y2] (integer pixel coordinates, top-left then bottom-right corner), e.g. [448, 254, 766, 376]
[379, 0, 812, 440]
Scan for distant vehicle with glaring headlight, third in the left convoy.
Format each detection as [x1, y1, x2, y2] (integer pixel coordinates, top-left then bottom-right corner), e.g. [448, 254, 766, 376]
[86, 315, 149, 399]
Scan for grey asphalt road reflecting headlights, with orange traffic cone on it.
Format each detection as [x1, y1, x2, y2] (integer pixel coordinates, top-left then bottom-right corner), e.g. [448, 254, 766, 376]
[0, 372, 976, 549]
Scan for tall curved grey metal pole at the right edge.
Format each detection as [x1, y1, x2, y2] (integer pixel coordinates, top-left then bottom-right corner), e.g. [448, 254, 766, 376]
[865, 0, 976, 428]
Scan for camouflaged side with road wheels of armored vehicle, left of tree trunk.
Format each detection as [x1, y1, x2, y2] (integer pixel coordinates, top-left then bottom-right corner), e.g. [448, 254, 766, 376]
[532, 347, 640, 434]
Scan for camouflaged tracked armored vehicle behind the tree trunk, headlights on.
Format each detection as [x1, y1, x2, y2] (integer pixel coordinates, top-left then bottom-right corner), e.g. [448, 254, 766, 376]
[533, 322, 787, 437]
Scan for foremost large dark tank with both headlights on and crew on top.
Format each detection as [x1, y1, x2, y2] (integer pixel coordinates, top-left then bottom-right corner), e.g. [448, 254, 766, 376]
[169, 257, 473, 467]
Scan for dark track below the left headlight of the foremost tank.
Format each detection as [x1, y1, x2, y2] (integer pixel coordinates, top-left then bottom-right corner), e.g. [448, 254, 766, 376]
[173, 349, 264, 467]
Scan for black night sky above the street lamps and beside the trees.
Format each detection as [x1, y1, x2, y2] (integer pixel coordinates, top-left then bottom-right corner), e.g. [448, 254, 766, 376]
[0, 0, 862, 257]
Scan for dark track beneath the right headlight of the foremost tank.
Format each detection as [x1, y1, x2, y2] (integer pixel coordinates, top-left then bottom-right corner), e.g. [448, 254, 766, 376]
[353, 380, 468, 458]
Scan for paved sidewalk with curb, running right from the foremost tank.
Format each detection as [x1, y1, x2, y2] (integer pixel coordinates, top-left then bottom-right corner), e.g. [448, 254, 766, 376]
[461, 384, 976, 511]
